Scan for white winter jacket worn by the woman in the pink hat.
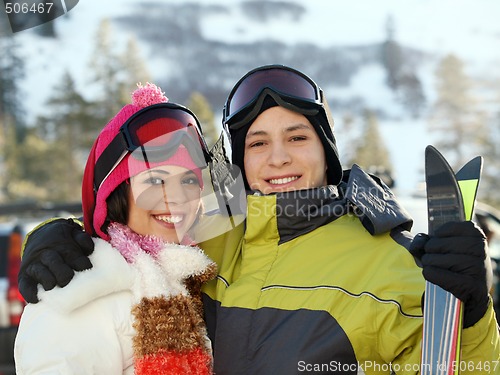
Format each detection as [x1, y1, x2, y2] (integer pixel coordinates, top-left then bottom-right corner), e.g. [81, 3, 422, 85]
[14, 235, 214, 375]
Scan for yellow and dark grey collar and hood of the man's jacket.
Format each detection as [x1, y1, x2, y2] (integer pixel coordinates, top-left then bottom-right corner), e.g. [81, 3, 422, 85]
[246, 164, 413, 243]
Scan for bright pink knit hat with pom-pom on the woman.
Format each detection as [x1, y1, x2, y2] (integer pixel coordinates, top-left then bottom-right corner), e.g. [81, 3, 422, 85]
[82, 83, 206, 240]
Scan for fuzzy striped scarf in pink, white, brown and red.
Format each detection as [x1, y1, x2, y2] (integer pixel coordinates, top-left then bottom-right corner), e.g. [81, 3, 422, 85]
[108, 223, 216, 375]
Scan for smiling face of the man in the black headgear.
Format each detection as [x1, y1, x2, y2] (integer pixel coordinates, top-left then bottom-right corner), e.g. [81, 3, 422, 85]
[244, 106, 327, 194]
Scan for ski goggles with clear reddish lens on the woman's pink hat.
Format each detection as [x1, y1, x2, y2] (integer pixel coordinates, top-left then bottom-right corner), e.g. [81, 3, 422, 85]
[94, 103, 210, 191]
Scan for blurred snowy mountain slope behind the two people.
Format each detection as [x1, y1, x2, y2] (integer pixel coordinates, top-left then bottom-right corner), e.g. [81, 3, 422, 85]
[9, 0, 500, 195]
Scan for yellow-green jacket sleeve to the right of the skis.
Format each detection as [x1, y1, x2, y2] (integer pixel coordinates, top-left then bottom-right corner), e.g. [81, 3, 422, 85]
[459, 298, 500, 375]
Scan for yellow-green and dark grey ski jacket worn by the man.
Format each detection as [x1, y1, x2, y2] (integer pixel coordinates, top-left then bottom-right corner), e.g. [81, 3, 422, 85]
[203, 167, 499, 375]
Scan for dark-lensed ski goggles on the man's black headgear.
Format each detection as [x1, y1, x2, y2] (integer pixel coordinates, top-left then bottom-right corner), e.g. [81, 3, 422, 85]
[223, 65, 323, 129]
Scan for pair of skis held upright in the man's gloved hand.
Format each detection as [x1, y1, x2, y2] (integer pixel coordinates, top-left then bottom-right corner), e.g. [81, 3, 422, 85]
[421, 146, 482, 375]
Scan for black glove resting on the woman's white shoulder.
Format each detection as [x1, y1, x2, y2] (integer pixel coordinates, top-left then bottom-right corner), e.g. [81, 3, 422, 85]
[18, 219, 94, 303]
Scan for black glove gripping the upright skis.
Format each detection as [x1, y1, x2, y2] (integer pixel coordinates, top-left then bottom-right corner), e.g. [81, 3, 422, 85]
[410, 221, 493, 328]
